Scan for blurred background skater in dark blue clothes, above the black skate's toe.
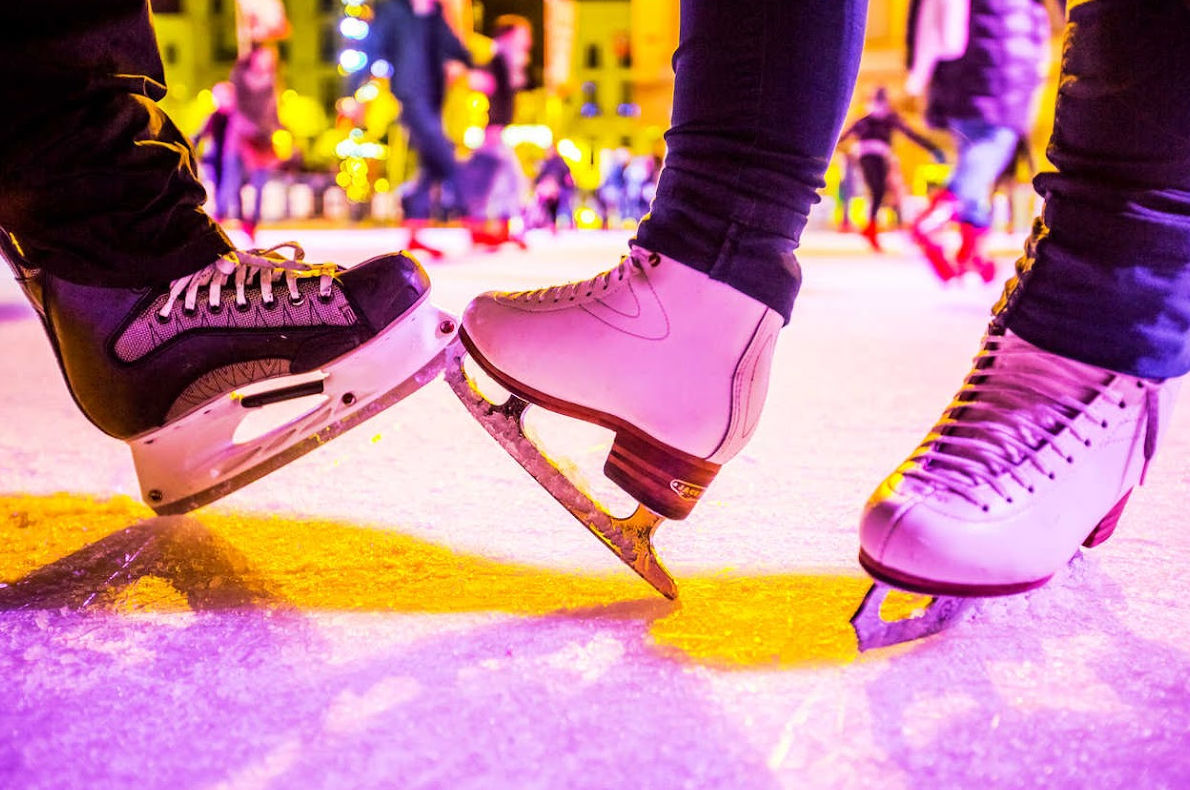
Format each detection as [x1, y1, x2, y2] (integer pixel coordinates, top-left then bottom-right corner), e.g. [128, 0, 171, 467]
[352, 0, 474, 257]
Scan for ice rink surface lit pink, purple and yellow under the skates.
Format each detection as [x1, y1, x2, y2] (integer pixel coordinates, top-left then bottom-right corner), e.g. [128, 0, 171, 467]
[0, 230, 1190, 790]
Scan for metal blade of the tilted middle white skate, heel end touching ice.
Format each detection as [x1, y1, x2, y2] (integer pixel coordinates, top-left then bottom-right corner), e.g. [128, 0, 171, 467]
[444, 340, 677, 598]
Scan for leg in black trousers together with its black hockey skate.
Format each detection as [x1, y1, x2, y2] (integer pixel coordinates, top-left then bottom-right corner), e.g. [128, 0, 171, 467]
[0, 0, 449, 513]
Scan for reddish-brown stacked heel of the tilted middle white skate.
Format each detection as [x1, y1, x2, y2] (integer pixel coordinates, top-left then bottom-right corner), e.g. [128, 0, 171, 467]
[603, 431, 720, 520]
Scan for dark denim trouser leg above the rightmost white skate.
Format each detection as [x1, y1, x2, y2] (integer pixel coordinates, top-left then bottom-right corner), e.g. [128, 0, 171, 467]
[997, 0, 1190, 378]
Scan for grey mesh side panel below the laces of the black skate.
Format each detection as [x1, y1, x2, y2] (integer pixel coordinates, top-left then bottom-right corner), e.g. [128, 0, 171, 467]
[115, 278, 356, 362]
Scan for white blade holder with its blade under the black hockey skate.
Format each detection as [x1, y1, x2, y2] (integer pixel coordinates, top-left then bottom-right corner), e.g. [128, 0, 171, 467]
[129, 299, 458, 515]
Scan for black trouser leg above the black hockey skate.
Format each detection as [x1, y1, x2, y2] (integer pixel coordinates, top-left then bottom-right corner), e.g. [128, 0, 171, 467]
[0, 0, 231, 287]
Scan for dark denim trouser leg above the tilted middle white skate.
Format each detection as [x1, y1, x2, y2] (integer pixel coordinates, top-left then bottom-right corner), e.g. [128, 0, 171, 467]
[637, 0, 868, 320]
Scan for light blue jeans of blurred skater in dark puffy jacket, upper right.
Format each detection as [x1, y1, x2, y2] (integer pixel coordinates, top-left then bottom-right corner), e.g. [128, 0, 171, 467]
[947, 119, 1020, 227]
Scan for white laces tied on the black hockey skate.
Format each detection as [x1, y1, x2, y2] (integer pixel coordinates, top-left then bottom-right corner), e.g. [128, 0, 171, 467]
[157, 242, 339, 319]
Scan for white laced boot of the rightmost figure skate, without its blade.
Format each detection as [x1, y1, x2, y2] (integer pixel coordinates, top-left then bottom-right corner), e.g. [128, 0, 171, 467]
[857, 332, 1179, 647]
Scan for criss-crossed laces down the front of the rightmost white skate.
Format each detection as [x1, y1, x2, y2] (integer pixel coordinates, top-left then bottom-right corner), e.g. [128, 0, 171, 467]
[903, 336, 1158, 509]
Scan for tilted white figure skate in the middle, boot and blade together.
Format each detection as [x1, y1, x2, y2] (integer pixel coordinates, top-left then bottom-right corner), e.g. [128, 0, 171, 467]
[446, 247, 783, 597]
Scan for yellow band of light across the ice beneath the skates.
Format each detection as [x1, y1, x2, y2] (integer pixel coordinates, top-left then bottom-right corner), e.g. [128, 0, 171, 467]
[0, 494, 868, 669]
